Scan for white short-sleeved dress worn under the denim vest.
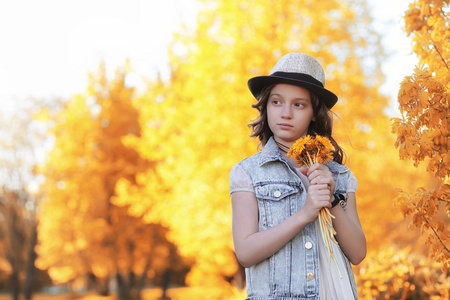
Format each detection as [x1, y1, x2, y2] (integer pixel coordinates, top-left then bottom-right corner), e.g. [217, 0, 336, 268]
[230, 165, 358, 300]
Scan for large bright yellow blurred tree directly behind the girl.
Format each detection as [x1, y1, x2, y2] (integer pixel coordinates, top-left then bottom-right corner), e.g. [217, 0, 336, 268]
[113, 0, 432, 292]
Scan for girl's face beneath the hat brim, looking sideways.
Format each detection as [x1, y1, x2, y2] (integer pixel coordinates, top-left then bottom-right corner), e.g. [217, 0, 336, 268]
[267, 83, 314, 147]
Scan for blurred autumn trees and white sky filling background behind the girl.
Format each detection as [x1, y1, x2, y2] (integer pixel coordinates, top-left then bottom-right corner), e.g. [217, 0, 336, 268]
[0, 0, 450, 300]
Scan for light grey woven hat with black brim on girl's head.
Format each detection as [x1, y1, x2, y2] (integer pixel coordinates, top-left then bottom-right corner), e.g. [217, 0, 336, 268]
[248, 53, 338, 108]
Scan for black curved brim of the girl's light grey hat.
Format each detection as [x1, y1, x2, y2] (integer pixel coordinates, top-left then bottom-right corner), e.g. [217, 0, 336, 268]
[248, 75, 338, 109]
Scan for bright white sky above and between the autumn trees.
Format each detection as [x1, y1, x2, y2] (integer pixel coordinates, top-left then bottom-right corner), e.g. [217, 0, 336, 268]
[0, 0, 417, 113]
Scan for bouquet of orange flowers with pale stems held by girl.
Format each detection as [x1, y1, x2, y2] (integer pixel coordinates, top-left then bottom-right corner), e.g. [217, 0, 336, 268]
[287, 135, 340, 274]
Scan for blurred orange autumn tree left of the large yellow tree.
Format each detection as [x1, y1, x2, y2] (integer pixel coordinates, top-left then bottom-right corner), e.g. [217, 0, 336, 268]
[37, 65, 186, 299]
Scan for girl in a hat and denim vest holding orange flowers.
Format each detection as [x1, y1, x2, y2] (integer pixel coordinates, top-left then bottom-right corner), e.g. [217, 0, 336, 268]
[230, 53, 366, 300]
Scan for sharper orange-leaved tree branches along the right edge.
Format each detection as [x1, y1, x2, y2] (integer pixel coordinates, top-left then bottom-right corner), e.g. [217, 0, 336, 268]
[392, 0, 450, 270]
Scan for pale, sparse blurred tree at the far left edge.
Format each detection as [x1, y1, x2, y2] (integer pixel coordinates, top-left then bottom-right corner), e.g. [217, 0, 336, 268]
[0, 99, 53, 299]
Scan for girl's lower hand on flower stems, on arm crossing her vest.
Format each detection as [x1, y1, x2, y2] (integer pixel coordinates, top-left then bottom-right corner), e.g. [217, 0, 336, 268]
[301, 183, 331, 223]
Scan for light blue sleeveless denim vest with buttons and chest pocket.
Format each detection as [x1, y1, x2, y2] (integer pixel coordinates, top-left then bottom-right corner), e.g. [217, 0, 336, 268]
[239, 138, 357, 300]
